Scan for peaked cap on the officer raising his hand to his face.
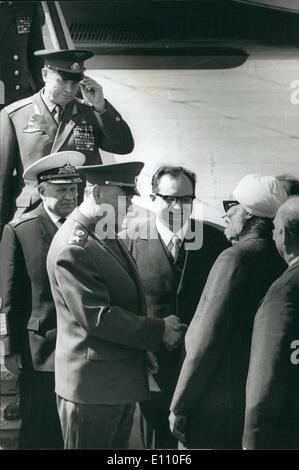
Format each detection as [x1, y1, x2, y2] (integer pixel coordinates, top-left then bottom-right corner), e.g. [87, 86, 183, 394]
[34, 49, 94, 81]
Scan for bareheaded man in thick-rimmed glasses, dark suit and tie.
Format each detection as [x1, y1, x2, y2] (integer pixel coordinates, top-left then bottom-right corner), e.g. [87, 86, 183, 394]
[120, 166, 228, 449]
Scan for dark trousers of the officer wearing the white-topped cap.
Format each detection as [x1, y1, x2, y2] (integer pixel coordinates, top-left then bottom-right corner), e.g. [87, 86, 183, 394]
[19, 371, 63, 449]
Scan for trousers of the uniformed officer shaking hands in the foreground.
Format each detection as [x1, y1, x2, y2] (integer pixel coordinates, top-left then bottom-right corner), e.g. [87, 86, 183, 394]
[57, 396, 135, 449]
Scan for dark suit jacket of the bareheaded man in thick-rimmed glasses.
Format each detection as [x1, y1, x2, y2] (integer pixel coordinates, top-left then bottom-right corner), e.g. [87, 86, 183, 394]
[120, 219, 228, 394]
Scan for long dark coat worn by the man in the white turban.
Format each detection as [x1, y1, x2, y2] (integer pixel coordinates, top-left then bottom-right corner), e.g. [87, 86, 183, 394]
[171, 233, 285, 449]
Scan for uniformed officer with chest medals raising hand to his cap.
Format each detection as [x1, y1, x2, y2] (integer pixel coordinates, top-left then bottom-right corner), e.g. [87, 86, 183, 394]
[0, 49, 134, 234]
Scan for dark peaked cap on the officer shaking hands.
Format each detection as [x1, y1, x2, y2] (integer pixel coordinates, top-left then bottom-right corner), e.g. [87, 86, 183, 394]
[77, 162, 144, 196]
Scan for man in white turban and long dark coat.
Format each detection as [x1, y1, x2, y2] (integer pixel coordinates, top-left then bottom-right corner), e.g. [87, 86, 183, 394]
[170, 175, 287, 449]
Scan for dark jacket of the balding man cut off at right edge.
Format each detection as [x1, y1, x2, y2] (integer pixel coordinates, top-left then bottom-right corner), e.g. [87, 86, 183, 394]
[243, 261, 299, 449]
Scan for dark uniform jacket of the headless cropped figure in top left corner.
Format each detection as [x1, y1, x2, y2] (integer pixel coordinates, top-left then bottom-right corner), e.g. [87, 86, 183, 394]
[0, 2, 44, 109]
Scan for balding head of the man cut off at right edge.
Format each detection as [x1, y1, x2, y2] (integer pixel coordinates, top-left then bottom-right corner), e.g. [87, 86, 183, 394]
[273, 196, 299, 263]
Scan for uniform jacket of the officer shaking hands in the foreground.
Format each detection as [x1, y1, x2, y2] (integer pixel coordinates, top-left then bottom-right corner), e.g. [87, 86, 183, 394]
[47, 209, 164, 405]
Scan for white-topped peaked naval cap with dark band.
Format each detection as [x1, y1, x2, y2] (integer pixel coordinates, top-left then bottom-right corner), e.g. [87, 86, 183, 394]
[23, 150, 85, 184]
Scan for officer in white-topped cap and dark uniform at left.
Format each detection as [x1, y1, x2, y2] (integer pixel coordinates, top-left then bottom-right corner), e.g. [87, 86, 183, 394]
[0, 151, 84, 449]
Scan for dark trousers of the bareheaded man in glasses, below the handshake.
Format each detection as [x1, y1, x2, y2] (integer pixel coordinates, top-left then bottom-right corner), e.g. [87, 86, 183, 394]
[140, 392, 178, 449]
